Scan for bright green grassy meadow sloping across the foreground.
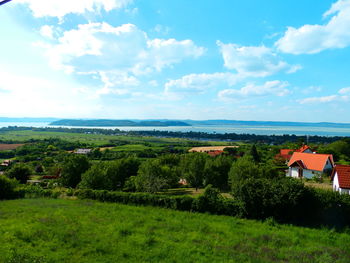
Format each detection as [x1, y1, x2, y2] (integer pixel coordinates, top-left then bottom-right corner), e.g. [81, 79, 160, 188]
[0, 199, 350, 263]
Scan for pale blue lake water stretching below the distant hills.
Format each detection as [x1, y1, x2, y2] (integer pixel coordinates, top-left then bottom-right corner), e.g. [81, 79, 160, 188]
[0, 122, 350, 136]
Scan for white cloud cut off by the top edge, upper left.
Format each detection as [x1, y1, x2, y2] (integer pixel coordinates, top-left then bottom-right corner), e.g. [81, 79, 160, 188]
[14, 0, 132, 19]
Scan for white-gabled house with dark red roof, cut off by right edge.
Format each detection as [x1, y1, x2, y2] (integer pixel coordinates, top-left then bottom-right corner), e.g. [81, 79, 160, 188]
[332, 165, 350, 194]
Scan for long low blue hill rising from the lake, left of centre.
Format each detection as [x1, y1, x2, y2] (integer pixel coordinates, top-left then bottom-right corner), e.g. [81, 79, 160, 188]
[50, 119, 191, 127]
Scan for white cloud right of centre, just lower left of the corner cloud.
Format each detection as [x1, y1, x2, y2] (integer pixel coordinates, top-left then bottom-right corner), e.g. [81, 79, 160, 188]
[217, 41, 301, 77]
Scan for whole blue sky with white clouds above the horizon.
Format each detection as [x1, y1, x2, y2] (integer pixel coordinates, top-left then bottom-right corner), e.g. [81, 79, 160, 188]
[0, 0, 350, 123]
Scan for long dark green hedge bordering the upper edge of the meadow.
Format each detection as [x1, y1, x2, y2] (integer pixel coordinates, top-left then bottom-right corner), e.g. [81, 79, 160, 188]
[22, 186, 350, 228]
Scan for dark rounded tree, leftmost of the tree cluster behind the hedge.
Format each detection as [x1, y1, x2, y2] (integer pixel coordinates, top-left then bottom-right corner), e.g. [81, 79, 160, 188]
[61, 154, 90, 188]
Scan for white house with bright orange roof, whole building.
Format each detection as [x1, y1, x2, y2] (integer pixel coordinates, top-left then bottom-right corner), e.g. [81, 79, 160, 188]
[287, 152, 334, 179]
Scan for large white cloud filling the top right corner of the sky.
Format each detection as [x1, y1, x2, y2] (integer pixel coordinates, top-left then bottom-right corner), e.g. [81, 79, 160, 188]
[275, 0, 350, 55]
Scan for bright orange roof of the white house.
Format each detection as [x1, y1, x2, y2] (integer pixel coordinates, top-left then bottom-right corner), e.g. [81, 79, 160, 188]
[288, 152, 334, 172]
